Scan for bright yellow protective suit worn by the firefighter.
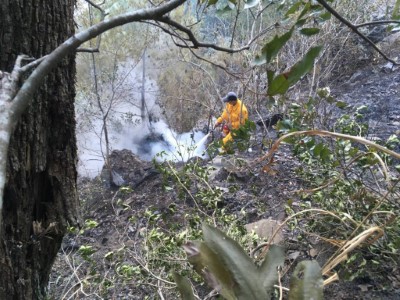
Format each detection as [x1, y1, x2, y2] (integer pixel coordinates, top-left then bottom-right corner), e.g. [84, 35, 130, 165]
[217, 99, 249, 145]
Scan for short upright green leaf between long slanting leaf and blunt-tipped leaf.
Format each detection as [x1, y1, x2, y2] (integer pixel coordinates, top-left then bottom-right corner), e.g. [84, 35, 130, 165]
[259, 245, 285, 294]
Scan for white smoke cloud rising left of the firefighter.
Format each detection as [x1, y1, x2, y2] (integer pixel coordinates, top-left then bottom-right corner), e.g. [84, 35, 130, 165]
[76, 58, 205, 178]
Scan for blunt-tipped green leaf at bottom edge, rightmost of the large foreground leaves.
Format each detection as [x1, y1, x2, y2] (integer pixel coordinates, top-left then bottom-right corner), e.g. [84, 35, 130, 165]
[289, 261, 323, 300]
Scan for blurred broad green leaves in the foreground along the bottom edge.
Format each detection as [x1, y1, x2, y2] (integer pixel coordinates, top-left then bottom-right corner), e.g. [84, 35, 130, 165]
[178, 224, 323, 300]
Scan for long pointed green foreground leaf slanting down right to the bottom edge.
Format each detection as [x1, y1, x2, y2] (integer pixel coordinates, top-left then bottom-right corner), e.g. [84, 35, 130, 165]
[203, 224, 269, 300]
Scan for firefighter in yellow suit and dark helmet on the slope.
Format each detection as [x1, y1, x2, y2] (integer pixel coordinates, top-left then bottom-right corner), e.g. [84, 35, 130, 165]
[214, 92, 248, 147]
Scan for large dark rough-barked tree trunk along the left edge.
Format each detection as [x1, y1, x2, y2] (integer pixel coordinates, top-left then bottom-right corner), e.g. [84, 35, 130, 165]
[0, 0, 78, 300]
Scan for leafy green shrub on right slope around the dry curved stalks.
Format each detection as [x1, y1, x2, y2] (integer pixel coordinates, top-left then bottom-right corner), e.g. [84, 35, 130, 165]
[277, 90, 400, 286]
